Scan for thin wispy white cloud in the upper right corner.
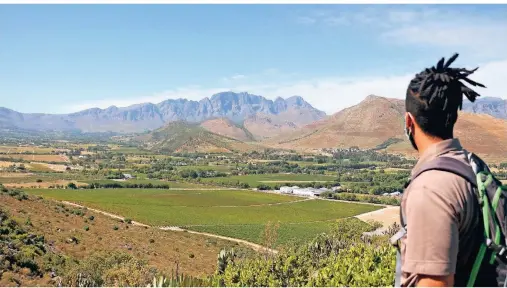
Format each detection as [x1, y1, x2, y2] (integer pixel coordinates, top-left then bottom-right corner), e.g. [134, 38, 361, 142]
[298, 5, 507, 59]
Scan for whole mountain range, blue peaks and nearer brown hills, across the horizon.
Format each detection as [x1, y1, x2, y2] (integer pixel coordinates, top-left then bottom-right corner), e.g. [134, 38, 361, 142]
[0, 92, 507, 159]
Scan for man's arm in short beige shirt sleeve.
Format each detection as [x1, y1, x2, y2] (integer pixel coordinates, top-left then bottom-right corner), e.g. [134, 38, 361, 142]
[402, 176, 459, 287]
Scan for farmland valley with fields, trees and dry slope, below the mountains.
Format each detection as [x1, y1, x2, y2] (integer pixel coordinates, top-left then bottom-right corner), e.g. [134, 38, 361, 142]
[0, 141, 507, 286]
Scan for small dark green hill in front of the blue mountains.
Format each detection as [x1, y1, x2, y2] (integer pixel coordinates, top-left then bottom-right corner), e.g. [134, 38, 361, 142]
[135, 121, 261, 153]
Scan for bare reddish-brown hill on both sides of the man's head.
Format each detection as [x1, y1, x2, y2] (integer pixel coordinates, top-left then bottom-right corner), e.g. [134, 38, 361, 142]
[265, 95, 507, 159]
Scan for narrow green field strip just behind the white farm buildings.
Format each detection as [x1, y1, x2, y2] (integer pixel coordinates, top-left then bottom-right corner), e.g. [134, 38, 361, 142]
[201, 174, 336, 187]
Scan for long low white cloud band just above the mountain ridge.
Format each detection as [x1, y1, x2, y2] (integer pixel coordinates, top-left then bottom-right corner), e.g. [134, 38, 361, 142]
[64, 58, 507, 114]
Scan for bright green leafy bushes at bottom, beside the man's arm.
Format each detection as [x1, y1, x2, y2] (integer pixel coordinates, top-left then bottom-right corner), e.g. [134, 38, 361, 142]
[211, 219, 396, 287]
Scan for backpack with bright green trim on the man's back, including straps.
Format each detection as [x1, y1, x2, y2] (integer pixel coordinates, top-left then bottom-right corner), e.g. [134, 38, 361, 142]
[391, 153, 507, 287]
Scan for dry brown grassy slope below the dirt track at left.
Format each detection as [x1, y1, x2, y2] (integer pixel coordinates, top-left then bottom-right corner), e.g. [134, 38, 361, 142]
[0, 195, 251, 276]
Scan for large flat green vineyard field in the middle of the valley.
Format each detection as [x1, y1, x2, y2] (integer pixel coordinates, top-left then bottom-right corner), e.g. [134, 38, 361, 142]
[27, 189, 380, 244]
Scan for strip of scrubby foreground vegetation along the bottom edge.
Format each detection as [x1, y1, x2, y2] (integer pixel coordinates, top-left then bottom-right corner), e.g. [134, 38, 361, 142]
[0, 186, 395, 287]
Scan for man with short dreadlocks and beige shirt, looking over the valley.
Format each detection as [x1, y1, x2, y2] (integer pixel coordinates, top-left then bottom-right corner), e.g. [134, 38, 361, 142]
[393, 54, 497, 287]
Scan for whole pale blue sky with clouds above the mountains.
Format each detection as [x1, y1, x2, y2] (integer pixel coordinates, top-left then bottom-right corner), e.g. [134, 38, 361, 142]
[0, 4, 507, 114]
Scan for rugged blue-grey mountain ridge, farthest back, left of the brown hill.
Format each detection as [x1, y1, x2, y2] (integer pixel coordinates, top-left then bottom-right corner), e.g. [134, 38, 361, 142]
[0, 92, 326, 133]
